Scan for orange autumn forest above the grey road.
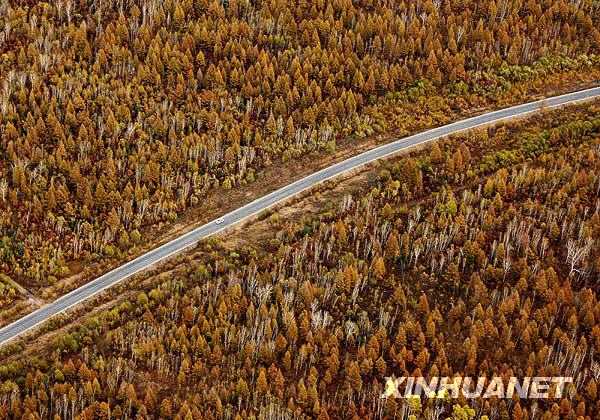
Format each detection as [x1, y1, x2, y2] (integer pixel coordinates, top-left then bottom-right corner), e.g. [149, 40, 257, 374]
[0, 0, 600, 307]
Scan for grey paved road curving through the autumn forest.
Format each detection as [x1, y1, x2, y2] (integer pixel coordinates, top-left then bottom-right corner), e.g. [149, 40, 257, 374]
[0, 87, 600, 345]
